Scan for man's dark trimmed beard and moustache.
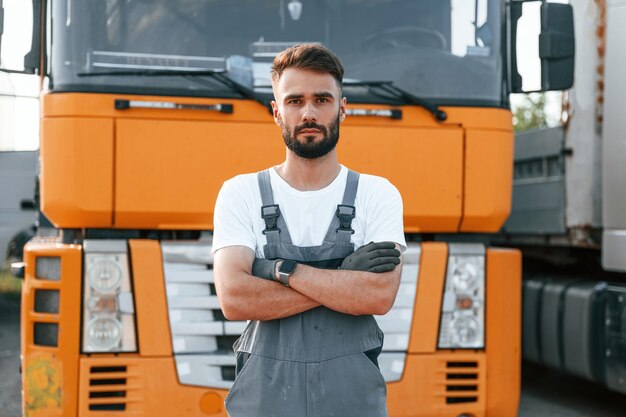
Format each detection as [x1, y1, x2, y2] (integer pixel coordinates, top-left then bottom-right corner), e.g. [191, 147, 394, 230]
[281, 114, 339, 159]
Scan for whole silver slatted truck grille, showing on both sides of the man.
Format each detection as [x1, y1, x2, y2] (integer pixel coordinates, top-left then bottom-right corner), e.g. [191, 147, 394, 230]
[161, 240, 421, 388]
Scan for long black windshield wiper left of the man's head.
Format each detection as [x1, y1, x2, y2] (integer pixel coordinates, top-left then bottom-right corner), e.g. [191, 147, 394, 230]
[76, 69, 271, 108]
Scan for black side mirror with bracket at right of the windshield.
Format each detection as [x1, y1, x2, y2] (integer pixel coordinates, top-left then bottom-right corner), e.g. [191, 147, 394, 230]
[508, 0, 575, 93]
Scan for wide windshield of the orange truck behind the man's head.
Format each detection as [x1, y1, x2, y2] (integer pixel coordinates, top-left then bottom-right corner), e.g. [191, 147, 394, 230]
[48, 0, 502, 106]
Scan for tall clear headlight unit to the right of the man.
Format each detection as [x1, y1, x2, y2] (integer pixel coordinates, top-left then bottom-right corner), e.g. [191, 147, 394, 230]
[438, 244, 485, 349]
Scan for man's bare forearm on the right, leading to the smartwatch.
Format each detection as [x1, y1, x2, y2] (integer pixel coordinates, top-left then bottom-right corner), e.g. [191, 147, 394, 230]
[289, 264, 402, 315]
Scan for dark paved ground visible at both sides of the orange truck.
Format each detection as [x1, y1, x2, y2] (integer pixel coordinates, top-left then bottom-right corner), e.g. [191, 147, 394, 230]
[0, 293, 626, 417]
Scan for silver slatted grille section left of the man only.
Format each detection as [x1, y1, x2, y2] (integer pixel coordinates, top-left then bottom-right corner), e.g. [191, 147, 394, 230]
[161, 241, 240, 388]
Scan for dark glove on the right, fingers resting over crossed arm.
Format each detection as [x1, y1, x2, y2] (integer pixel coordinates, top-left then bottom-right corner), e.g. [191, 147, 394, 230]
[339, 242, 400, 272]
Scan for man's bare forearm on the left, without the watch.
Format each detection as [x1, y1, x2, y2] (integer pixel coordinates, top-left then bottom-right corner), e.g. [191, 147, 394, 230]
[217, 272, 320, 320]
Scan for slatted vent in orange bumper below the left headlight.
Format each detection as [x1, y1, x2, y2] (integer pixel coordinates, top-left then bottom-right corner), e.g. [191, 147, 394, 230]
[88, 366, 127, 411]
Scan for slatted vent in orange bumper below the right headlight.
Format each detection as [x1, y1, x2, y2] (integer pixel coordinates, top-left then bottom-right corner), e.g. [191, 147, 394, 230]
[446, 361, 478, 404]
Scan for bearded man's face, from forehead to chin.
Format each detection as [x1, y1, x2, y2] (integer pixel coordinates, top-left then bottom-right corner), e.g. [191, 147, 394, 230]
[272, 68, 346, 159]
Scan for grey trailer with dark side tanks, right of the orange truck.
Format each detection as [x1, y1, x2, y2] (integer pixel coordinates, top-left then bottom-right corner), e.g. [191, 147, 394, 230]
[500, 0, 626, 393]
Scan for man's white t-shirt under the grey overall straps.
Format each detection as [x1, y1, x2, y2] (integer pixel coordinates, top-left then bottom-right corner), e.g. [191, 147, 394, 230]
[211, 165, 406, 258]
